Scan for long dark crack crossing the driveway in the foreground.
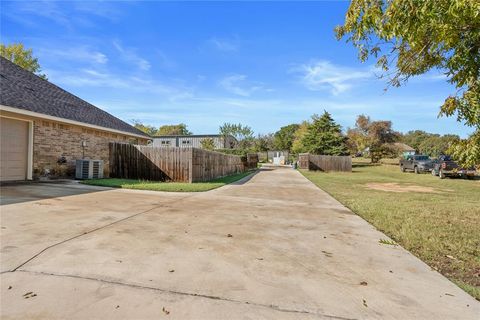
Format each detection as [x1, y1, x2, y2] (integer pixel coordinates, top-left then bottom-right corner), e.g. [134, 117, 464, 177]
[17, 269, 356, 320]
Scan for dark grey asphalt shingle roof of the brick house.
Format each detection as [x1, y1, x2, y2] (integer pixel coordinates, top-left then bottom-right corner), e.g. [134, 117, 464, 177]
[0, 57, 148, 137]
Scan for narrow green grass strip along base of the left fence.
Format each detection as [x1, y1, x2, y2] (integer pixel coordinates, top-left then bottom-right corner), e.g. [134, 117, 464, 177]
[82, 171, 254, 192]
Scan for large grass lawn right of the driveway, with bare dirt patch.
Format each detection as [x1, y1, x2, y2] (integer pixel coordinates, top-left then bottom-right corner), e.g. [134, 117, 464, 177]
[301, 163, 480, 300]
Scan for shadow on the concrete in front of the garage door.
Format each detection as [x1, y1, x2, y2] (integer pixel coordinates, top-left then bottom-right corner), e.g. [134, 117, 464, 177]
[0, 180, 110, 205]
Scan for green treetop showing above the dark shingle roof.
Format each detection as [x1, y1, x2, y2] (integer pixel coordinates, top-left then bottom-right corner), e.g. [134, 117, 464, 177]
[0, 43, 47, 80]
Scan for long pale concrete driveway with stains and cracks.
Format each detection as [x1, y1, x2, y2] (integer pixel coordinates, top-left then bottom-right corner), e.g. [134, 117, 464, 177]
[0, 168, 480, 319]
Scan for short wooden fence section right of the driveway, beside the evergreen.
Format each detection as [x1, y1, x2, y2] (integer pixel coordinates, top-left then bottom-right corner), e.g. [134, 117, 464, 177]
[298, 153, 352, 172]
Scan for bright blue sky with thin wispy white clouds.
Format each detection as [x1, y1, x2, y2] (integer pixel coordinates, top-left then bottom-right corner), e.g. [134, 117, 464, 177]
[0, 1, 471, 136]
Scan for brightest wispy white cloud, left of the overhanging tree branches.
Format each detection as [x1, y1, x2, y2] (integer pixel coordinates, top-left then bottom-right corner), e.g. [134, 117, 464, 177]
[291, 60, 374, 95]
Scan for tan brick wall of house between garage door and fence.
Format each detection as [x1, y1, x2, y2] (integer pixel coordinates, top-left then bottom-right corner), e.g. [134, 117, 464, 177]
[33, 119, 147, 178]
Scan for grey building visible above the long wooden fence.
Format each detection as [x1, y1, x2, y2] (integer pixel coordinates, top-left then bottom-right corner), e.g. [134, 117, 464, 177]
[152, 134, 237, 149]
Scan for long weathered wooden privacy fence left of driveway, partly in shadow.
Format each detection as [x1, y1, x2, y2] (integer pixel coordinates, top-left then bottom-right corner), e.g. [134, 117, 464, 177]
[110, 143, 251, 182]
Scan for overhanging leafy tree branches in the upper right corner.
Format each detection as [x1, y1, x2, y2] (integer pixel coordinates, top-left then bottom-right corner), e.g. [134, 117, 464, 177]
[335, 0, 480, 168]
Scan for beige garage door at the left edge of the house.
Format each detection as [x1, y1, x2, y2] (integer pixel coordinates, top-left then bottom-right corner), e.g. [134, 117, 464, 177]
[0, 118, 28, 181]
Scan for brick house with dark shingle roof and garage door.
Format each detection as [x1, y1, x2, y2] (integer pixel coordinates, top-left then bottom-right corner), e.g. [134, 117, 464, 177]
[0, 57, 150, 181]
